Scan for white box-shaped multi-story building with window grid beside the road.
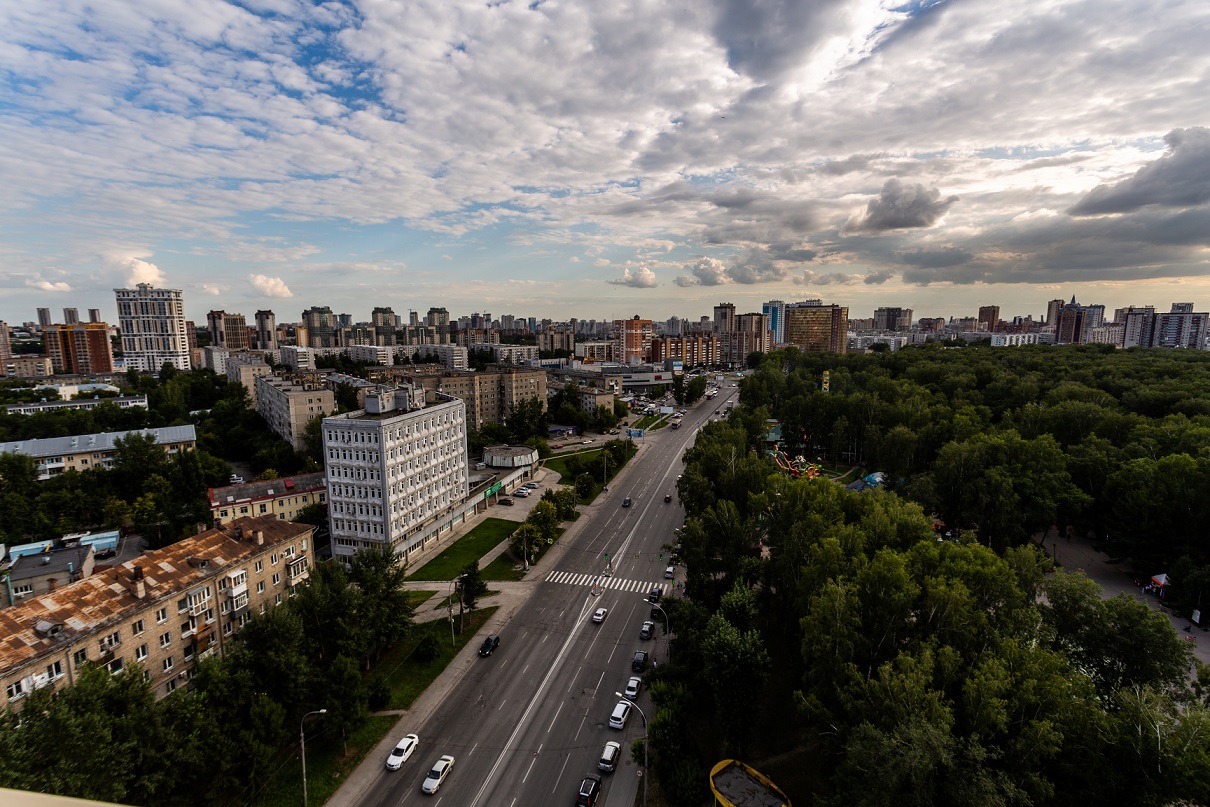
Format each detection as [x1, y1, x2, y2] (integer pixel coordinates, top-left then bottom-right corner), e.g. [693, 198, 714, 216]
[323, 387, 468, 560]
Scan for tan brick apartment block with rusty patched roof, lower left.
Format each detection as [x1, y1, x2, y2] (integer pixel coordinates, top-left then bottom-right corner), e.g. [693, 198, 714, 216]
[0, 518, 315, 709]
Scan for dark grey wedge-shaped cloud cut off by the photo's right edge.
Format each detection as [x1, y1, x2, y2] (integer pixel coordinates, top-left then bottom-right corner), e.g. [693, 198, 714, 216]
[1068, 126, 1210, 215]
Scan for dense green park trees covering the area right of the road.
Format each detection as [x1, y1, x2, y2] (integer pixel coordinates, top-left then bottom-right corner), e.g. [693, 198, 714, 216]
[650, 348, 1210, 807]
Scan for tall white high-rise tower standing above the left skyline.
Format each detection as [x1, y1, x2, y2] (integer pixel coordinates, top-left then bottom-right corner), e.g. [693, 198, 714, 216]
[114, 283, 191, 373]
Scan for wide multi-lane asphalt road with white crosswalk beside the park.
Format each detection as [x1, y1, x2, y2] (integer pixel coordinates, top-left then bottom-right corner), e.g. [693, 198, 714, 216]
[361, 379, 738, 807]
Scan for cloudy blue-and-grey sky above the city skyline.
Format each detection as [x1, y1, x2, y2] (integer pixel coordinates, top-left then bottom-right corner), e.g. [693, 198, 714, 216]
[0, 0, 1210, 323]
